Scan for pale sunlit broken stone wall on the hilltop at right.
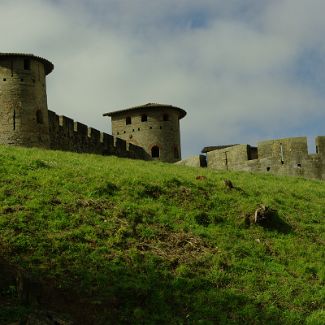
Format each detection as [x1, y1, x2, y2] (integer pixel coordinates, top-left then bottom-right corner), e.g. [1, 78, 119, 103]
[207, 137, 325, 179]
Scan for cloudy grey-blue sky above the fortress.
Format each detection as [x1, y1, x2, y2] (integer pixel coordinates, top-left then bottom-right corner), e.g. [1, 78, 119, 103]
[0, 0, 325, 157]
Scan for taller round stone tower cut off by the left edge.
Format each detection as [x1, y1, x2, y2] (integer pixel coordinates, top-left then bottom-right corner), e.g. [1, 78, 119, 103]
[0, 53, 54, 148]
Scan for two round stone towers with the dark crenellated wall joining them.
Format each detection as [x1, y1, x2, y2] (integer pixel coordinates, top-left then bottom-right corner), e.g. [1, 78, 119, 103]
[0, 53, 181, 162]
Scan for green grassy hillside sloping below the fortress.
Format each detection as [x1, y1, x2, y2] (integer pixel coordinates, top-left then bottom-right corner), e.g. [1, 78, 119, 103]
[0, 146, 325, 324]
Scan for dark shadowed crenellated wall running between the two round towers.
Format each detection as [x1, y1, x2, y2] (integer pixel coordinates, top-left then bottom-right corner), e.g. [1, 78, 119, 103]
[48, 111, 150, 160]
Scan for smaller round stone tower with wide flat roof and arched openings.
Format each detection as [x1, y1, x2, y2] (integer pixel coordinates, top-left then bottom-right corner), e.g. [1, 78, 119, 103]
[104, 103, 186, 163]
